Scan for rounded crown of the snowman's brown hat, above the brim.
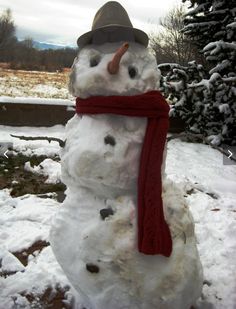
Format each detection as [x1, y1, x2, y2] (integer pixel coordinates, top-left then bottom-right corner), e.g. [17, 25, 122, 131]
[92, 1, 133, 30]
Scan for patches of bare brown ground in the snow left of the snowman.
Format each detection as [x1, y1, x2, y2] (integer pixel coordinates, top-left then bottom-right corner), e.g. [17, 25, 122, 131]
[0, 154, 72, 309]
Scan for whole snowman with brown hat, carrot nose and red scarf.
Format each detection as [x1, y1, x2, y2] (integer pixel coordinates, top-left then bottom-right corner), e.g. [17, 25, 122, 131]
[50, 1, 203, 309]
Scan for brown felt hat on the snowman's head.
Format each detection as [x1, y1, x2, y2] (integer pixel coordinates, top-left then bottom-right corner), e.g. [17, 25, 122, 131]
[77, 1, 149, 48]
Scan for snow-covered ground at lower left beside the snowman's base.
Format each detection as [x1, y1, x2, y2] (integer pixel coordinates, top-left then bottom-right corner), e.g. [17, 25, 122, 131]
[0, 190, 72, 309]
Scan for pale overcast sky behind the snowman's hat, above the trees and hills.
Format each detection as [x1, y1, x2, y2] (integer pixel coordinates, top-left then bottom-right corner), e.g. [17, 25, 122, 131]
[0, 0, 182, 46]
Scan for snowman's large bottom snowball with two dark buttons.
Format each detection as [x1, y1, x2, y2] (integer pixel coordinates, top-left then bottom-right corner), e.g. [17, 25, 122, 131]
[50, 181, 202, 309]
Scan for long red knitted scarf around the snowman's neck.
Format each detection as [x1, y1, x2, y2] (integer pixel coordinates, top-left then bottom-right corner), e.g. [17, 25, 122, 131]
[76, 91, 172, 256]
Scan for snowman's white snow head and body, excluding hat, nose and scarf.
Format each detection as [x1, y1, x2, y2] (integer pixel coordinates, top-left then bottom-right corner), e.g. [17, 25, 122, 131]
[51, 43, 202, 309]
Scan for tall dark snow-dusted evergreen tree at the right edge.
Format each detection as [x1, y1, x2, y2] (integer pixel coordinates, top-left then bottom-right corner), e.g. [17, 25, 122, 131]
[166, 0, 236, 145]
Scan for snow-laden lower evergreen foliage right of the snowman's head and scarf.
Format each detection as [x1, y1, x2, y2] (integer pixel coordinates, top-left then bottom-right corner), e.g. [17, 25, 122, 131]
[158, 62, 236, 145]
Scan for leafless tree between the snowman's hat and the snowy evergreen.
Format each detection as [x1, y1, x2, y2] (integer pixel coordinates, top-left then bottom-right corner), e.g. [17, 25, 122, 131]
[150, 5, 197, 65]
